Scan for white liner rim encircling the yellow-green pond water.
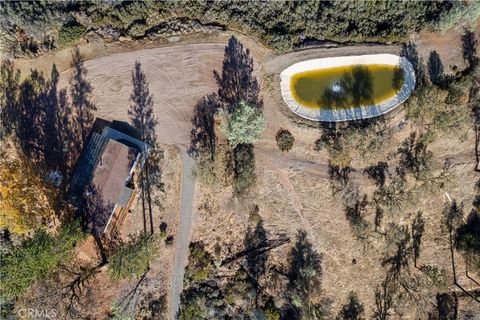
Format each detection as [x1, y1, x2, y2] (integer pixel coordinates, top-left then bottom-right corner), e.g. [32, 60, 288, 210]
[280, 54, 415, 122]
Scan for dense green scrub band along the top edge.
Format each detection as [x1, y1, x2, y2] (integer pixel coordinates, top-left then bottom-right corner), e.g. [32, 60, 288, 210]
[0, 1, 480, 54]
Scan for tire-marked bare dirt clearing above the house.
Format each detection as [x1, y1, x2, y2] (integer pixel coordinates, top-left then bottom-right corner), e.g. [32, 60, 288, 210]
[60, 43, 224, 146]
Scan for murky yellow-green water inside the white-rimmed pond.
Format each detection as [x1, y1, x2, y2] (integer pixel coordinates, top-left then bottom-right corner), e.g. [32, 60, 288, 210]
[290, 64, 404, 109]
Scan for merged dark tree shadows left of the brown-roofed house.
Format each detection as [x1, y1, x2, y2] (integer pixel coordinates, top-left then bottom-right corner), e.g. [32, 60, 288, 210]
[2, 48, 96, 182]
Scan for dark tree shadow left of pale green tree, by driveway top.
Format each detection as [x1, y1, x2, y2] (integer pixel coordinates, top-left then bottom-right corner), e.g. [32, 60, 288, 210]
[188, 94, 220, 160]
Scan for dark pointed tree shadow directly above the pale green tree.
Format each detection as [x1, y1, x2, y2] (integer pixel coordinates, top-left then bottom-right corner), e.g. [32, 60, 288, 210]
[214, 36, 263, 111]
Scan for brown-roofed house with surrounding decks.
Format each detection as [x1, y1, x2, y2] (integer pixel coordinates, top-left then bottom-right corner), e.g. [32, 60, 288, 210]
[69, 118, 150, 237]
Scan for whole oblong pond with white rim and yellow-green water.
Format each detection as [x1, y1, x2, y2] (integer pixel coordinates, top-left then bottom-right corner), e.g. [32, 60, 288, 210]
[280, 54, 415, 122]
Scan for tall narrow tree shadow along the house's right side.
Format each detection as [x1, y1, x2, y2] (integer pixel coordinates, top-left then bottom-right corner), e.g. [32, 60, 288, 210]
[128, 62, 163, 234]
